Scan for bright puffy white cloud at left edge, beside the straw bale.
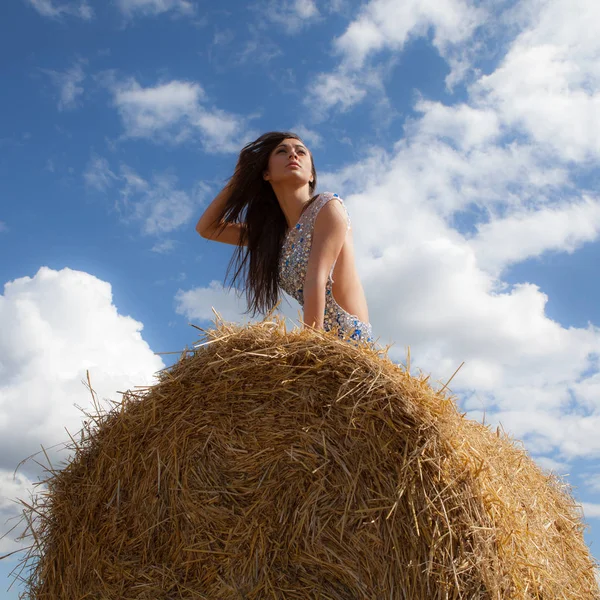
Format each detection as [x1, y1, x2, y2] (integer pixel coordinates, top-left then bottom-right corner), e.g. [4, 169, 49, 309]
[0, 267, 164, 553]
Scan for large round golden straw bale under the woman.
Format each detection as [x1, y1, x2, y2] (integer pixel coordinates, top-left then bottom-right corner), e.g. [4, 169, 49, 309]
[16, 316, 600, 600]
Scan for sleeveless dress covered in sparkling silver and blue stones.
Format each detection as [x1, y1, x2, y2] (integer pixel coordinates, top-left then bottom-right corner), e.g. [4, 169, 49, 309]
[279, 192, 373, 343]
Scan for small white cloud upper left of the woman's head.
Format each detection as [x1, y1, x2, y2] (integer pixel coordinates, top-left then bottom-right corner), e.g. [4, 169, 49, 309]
[108, 78, 250, 153]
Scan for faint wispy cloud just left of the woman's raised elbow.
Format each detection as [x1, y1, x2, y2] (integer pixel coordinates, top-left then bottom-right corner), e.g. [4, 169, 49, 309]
[83, 155, 209, 237]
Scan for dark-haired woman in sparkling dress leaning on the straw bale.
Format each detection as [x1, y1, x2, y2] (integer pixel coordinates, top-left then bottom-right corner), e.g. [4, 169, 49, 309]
[196, 132, 373, 343]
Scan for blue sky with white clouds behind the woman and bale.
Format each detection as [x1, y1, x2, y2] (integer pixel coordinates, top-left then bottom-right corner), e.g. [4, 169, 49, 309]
[0, 0, 600, 598]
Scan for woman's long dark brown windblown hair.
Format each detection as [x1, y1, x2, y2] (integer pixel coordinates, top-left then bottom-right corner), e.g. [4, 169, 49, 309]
[216, 131, 317, 317]
